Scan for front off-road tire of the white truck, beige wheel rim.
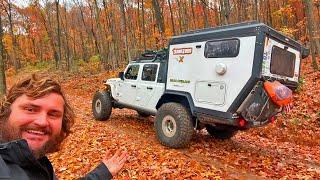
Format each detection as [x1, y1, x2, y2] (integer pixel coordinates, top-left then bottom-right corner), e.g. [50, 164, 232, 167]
[92, 91, 112, 121]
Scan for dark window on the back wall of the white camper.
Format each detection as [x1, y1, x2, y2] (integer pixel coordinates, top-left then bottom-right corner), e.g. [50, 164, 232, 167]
[270, 46, 296, 77]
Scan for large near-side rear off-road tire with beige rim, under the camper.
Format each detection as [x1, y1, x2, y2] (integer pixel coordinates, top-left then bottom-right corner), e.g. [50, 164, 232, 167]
[154, 103, 194, 148]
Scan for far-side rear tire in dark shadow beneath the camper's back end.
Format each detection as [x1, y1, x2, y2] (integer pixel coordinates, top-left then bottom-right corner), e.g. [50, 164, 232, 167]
[206, 125, 238, 139]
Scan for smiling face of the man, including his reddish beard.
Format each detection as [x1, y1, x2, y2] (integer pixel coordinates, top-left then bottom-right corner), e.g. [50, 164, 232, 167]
[3, 93, 64, 155]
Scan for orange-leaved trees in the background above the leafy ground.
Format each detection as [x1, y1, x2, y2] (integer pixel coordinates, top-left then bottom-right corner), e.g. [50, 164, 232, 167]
[0, 0, 320, 70]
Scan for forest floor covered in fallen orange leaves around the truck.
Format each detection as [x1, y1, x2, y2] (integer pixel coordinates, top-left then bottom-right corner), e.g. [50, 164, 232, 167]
[8, 60, 320, 179]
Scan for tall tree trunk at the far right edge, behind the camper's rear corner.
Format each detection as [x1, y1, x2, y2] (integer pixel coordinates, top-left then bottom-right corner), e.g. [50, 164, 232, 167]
[303, 0, 320, 71]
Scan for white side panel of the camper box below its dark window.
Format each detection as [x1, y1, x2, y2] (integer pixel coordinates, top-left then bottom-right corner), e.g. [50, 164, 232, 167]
[167, 36, 256, 112]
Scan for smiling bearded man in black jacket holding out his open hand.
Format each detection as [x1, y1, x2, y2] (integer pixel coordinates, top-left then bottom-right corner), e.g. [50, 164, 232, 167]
[0, 75, 128, 180]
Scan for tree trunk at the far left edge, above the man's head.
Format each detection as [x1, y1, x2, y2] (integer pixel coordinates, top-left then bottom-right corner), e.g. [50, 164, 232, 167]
[0, 13, 6, 98]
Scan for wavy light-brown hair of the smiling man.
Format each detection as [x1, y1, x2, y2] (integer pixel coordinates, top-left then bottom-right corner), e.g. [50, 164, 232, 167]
[0, 74, 75, 139]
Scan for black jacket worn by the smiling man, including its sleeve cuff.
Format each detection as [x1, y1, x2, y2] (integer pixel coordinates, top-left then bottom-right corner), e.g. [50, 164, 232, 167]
[0, 140, 112, 180]
